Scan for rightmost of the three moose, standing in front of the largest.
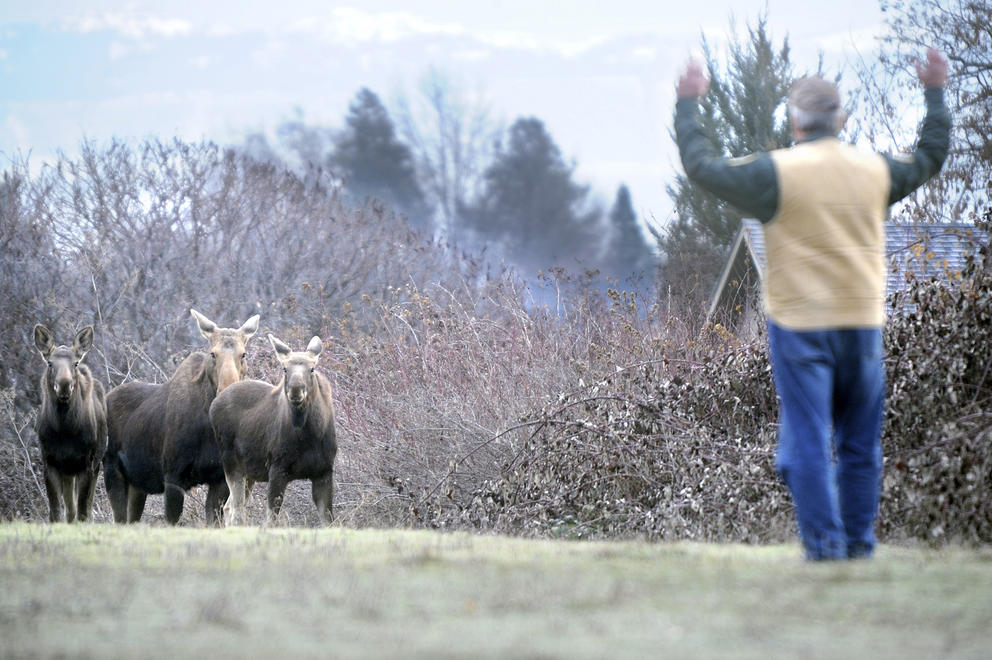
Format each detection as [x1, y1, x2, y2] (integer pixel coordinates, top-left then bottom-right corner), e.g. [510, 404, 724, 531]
[210, 335, 337, 525]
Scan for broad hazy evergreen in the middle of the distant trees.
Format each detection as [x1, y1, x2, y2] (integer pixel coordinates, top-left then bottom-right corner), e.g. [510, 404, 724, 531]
[460, 117, 602, 270]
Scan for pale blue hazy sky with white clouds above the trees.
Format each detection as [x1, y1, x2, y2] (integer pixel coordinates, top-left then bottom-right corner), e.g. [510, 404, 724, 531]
[0, 0, 882, 227]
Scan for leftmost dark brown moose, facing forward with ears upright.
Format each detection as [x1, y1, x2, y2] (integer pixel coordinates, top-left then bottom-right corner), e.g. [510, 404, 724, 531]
[34, 323, 107, 522]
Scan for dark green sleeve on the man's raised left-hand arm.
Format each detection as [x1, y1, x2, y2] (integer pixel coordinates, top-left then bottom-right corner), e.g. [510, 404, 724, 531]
[675, 98, 778, 222]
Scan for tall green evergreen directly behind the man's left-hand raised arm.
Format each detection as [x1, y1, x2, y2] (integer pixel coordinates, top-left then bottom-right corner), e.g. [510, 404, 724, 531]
[659, 15, 793, 303]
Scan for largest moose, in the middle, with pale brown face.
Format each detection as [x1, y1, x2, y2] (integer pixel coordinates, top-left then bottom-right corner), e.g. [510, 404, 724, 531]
[103, 309, 258, 525]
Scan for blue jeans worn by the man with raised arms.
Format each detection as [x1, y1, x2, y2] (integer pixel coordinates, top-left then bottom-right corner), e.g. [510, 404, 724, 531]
[768, 322, 885, 560]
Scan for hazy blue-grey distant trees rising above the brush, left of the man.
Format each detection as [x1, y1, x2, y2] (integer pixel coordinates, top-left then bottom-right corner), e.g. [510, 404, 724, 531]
[238, 72, 657, 291]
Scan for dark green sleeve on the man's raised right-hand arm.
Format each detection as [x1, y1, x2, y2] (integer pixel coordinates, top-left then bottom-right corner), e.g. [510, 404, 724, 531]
[885, 87, 951, 204]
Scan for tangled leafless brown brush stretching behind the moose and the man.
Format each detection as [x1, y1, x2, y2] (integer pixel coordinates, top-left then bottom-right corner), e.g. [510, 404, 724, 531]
[0, 142, 992, 544]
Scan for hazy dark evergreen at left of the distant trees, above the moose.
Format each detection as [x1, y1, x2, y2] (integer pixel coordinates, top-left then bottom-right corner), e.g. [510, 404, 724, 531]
[328, 88, 429, 226]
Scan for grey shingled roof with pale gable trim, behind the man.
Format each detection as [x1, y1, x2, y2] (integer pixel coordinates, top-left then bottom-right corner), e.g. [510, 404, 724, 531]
[708, 219, 977, 324]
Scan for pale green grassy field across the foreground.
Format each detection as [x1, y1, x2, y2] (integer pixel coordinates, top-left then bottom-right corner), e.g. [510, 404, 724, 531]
[0, 523, 992, 658]
